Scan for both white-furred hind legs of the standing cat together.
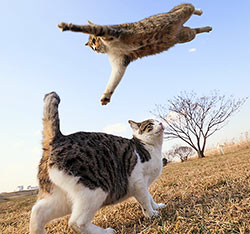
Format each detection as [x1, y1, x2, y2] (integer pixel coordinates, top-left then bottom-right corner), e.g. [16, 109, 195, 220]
[30, 168, 114, 234]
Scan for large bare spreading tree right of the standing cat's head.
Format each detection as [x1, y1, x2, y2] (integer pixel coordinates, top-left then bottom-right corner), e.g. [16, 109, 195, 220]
[153, 91, 247, 158]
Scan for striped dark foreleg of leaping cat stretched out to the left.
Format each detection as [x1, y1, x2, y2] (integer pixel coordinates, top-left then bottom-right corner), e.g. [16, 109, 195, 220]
[57, 21, 125, 38]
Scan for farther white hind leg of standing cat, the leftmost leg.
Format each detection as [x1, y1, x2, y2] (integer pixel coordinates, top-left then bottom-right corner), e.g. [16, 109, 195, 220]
[30, 186, 71, 234]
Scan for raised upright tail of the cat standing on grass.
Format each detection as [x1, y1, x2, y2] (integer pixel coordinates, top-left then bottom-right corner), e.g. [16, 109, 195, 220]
[43, 92, 61, 149]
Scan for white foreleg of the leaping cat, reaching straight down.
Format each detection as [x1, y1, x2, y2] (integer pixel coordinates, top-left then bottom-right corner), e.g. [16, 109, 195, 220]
[101, 54, 130, 105]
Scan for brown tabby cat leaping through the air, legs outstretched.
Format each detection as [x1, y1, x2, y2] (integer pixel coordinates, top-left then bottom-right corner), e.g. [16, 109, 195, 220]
[58, 4, 212, 105]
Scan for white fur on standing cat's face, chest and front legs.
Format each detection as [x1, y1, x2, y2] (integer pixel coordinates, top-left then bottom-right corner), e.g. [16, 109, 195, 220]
[126, 121, 165, 217]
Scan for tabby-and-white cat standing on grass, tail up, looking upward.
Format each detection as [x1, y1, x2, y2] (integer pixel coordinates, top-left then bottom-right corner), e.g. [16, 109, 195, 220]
[30, 92, 165, 234]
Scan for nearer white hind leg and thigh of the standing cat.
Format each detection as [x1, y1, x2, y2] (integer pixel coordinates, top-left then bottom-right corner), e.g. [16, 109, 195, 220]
[49, 168, 114, 234]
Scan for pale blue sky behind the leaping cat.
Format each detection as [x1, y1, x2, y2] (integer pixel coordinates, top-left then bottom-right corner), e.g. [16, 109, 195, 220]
[0, 0, 250, 192]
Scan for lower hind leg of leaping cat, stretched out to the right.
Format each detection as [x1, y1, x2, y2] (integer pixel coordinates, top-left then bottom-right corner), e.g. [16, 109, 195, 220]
[177, 26, 212, 43]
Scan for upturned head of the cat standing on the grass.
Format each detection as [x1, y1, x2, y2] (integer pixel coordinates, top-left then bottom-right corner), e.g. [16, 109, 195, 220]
[128, 119, 164, 145]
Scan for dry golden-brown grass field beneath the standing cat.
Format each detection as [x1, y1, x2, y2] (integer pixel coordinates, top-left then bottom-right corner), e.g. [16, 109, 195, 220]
[0, 147, 250, 234]
